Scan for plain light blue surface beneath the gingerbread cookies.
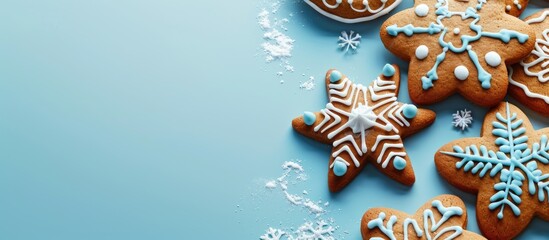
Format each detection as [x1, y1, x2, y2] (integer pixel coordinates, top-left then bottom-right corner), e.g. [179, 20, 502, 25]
[0, 0, 549, 240]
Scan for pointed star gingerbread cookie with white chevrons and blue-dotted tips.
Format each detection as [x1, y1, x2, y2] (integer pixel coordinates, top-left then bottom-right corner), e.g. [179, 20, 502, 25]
[292, 64, 435, 192]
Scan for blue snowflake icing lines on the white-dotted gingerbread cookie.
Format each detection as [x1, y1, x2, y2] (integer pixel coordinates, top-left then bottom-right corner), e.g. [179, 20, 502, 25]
[386, 0, 529, 90]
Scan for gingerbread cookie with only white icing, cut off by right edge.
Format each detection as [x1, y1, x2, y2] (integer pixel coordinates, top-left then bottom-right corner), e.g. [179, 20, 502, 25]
[509, 9, 549, 116]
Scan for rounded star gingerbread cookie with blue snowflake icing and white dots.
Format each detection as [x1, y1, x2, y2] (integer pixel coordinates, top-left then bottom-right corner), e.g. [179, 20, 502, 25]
[380, 0, 535, 106]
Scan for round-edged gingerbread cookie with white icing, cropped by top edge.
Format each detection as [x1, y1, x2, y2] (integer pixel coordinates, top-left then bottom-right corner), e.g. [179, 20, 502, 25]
[305, 0, 402, 23]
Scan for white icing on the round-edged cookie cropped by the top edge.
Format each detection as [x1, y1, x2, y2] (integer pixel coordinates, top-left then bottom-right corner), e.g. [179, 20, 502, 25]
[305, 0, 402, 23]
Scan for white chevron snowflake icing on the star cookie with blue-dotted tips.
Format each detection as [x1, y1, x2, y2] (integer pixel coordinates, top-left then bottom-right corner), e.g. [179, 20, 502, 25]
[313, 75, 410, 171]
